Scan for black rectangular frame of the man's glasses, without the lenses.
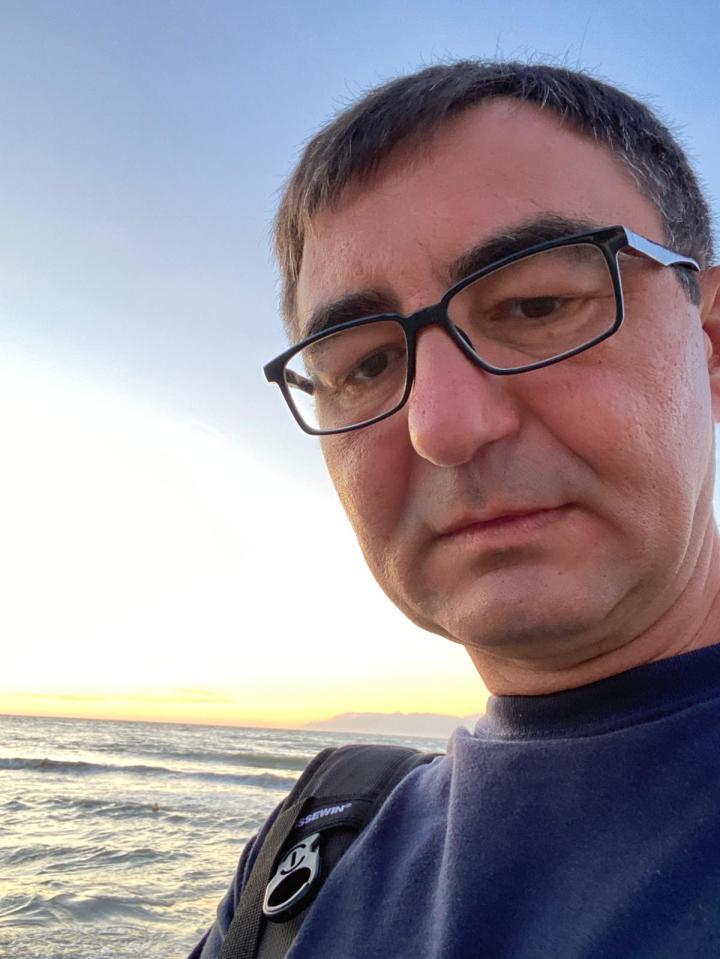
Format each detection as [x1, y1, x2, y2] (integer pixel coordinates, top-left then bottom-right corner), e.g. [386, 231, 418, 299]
[263, 226, 700, 436]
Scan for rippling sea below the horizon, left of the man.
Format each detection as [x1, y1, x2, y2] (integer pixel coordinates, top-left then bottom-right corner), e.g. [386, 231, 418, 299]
[0, 716, 446, 959]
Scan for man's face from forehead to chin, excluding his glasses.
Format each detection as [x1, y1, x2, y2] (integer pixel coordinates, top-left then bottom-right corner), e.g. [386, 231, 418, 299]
[298, 101, 713, 684]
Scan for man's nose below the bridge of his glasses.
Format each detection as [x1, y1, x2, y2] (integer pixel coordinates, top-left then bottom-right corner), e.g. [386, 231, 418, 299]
[407, 327, 520, 466]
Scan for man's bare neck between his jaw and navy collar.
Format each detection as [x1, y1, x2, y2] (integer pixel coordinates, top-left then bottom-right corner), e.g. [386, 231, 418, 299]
[468, 522, 720, 696]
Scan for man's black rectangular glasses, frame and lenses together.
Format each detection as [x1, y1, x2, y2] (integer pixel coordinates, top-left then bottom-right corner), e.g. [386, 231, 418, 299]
[264, 226, 700, 435]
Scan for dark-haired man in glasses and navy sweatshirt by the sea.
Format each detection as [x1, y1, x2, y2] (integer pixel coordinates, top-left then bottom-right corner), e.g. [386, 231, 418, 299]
[194, 62, 720, 959]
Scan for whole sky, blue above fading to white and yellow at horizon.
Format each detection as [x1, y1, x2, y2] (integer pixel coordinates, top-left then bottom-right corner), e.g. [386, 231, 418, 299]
[0, 0, 720, 726]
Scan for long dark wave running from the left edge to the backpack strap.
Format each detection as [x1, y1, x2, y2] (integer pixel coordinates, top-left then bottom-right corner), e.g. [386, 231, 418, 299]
[0, 756, 295, 790]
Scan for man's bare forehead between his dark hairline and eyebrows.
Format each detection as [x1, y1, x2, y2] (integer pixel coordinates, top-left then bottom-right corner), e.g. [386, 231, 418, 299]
[297, 100, 664, 335]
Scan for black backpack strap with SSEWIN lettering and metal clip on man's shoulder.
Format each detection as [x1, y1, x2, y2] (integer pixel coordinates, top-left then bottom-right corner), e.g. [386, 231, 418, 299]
[219, 745, 437, 959]
